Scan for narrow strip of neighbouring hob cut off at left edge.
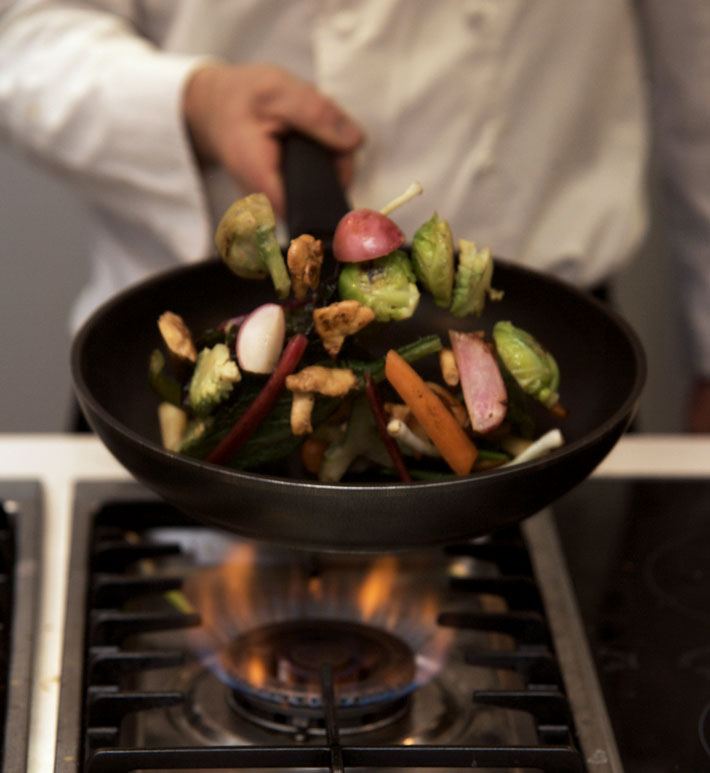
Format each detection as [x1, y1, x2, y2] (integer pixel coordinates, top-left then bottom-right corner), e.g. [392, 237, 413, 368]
[0, 481, 41, 773]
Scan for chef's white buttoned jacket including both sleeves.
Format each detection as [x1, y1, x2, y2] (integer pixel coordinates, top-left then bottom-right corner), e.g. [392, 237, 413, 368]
[0, 0, 710, 374]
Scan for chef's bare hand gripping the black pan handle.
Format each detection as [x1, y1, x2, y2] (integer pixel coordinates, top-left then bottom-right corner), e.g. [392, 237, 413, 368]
[183, 64, 363, 215]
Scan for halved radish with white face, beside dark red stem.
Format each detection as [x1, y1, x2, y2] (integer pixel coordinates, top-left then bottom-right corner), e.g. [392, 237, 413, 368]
[236, 303, 286, 373]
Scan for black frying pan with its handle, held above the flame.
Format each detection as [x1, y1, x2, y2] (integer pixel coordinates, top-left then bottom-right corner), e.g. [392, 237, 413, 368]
[72, 138, 645, 551]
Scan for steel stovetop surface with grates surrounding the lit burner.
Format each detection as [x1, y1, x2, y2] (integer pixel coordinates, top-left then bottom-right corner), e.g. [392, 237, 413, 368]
[57, 484, 596, 773]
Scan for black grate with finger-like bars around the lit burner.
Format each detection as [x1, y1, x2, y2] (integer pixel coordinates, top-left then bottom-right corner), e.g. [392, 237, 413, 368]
[56, 484, 587, 773]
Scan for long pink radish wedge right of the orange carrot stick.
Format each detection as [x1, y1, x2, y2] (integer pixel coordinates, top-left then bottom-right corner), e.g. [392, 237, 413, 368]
[449, 330, 508, 434]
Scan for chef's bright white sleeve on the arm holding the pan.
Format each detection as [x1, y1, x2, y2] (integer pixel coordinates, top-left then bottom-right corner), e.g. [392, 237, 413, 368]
[0, 0, 216, 261]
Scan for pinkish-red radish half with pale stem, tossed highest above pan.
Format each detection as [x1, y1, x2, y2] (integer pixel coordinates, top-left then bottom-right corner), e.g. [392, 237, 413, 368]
[333, 183, 422, 263]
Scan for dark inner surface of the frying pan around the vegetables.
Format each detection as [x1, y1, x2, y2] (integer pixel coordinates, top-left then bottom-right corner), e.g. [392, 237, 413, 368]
[74, 260, 642, 456]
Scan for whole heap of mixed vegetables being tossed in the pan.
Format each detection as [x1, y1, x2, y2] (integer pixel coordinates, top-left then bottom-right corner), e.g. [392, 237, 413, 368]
[148, 185, 563, 483]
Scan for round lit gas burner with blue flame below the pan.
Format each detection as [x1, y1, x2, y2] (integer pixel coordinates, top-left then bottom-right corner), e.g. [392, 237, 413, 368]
[218, 619, 416, 735]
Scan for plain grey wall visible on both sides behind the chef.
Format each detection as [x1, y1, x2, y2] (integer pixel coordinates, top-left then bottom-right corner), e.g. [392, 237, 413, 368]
[0, 145, 688, 432]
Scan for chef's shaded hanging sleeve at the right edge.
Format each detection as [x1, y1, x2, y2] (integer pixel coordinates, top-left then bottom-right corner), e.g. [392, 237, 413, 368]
[637, 0, 710, 377]
